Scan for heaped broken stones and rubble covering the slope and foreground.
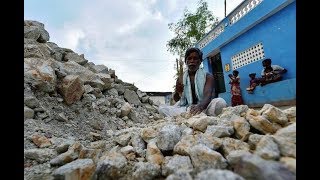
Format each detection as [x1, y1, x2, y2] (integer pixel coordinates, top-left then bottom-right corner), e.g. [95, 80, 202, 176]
[24, 20, 296, 180]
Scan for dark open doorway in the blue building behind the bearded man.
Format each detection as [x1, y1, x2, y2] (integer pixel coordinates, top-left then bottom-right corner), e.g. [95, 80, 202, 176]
[210, 53, 226, 97]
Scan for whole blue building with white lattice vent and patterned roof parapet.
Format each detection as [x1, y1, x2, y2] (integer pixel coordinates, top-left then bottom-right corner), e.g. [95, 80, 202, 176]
[196, 0, 296, 107]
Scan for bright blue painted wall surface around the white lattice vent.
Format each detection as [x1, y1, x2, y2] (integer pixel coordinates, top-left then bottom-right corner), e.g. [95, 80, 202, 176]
[202, 0, 296, 105]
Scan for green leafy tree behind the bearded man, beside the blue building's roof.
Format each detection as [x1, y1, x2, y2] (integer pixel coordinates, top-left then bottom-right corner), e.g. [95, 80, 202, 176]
[167, 0, 219, 58]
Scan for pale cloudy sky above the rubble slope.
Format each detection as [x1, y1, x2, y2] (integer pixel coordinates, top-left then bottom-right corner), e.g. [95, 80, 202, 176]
[24, 0, 243, 92]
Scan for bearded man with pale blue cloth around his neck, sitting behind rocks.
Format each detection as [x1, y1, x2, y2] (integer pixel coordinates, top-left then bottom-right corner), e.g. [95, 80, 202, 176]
[159, 48, 227, 116]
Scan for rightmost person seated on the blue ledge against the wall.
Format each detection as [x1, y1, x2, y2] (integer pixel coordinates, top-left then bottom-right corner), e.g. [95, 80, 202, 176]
[260, 58, 287, 86]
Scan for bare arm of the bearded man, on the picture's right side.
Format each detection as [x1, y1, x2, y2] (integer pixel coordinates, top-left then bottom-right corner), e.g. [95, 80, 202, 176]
[190, 73, 214, 114]
